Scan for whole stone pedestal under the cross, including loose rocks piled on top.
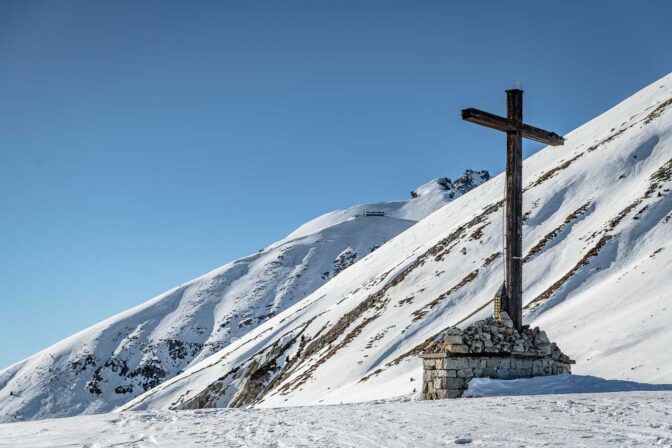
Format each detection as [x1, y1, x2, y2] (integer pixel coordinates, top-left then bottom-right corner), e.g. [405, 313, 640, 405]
[421, 312, 574, 400]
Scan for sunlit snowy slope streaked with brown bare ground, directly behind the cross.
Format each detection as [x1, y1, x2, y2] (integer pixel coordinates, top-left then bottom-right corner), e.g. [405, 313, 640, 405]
[125, 75, 672, 409]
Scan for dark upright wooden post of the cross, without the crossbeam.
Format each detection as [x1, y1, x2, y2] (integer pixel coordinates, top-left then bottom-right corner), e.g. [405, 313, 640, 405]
[503, 89, 523, 330]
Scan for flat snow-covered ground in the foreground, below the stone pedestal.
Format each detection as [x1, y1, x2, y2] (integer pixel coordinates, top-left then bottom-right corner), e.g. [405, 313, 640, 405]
[0, 392, 672, 448]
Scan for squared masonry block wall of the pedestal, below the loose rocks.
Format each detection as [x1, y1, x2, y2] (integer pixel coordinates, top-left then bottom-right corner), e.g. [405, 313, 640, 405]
[421, 353, 571, 400]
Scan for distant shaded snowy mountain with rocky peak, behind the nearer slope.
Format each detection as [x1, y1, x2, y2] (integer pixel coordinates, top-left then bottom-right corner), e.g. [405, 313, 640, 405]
[0, 170, 489, 421]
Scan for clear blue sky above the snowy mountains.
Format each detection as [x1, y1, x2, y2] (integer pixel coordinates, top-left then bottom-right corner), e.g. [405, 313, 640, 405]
[0, 0, 672, 367]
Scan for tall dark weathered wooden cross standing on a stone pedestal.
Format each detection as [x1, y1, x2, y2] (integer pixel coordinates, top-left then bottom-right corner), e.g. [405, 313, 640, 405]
[462, 89, 565, 330]
